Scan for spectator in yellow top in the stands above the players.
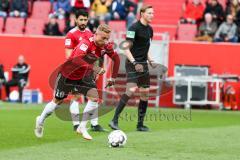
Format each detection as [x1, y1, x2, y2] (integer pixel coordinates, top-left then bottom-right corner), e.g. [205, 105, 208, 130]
[92, 0, 112, 20]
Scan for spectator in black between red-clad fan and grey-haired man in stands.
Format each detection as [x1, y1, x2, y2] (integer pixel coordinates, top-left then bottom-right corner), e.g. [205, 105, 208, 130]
[204, 0, 224, 25]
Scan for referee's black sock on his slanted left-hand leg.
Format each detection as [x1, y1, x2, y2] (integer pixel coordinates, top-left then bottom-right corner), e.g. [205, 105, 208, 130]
[112, 94, 130, 123]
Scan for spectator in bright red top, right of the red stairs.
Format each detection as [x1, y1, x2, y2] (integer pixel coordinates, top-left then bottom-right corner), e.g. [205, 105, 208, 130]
[180, 0, 204, 24]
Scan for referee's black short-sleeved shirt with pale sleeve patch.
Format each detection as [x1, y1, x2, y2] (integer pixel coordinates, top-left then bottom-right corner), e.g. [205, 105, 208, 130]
[127, 21, 153, 62]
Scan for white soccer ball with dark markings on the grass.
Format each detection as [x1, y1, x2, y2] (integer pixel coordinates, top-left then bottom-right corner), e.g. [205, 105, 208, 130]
[108, 130, 127, 147]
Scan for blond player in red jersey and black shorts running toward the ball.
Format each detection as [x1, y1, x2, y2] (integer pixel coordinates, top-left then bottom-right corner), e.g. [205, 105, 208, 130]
[35, 24, 120, 140]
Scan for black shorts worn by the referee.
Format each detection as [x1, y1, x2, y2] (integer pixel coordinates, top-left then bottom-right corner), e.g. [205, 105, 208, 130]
[125, 60, 150, 88]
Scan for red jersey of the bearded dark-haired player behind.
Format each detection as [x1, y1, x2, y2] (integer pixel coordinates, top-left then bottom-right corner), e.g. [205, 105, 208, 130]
[65, 27, 93, 49]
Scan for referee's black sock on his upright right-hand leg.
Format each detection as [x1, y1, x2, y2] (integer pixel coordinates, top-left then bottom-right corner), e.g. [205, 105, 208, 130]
[137, 100, 148, 127]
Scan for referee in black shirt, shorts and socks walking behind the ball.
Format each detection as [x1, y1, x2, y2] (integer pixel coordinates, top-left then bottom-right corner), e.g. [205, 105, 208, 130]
[109, 5, 154, 131]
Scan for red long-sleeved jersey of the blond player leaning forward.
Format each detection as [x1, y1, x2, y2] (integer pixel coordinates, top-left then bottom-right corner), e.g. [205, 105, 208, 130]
[61, 37, 120, 80]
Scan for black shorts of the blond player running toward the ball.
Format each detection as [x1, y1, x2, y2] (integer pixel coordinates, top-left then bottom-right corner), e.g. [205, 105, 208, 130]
[54, 73, 97, 100]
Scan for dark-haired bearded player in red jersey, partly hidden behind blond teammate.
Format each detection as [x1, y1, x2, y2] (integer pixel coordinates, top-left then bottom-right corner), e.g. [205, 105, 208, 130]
[65, 9, 104, 131]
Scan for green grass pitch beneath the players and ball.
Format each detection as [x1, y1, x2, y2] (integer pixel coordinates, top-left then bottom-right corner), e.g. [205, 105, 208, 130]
[0, 102, 240, 160]
